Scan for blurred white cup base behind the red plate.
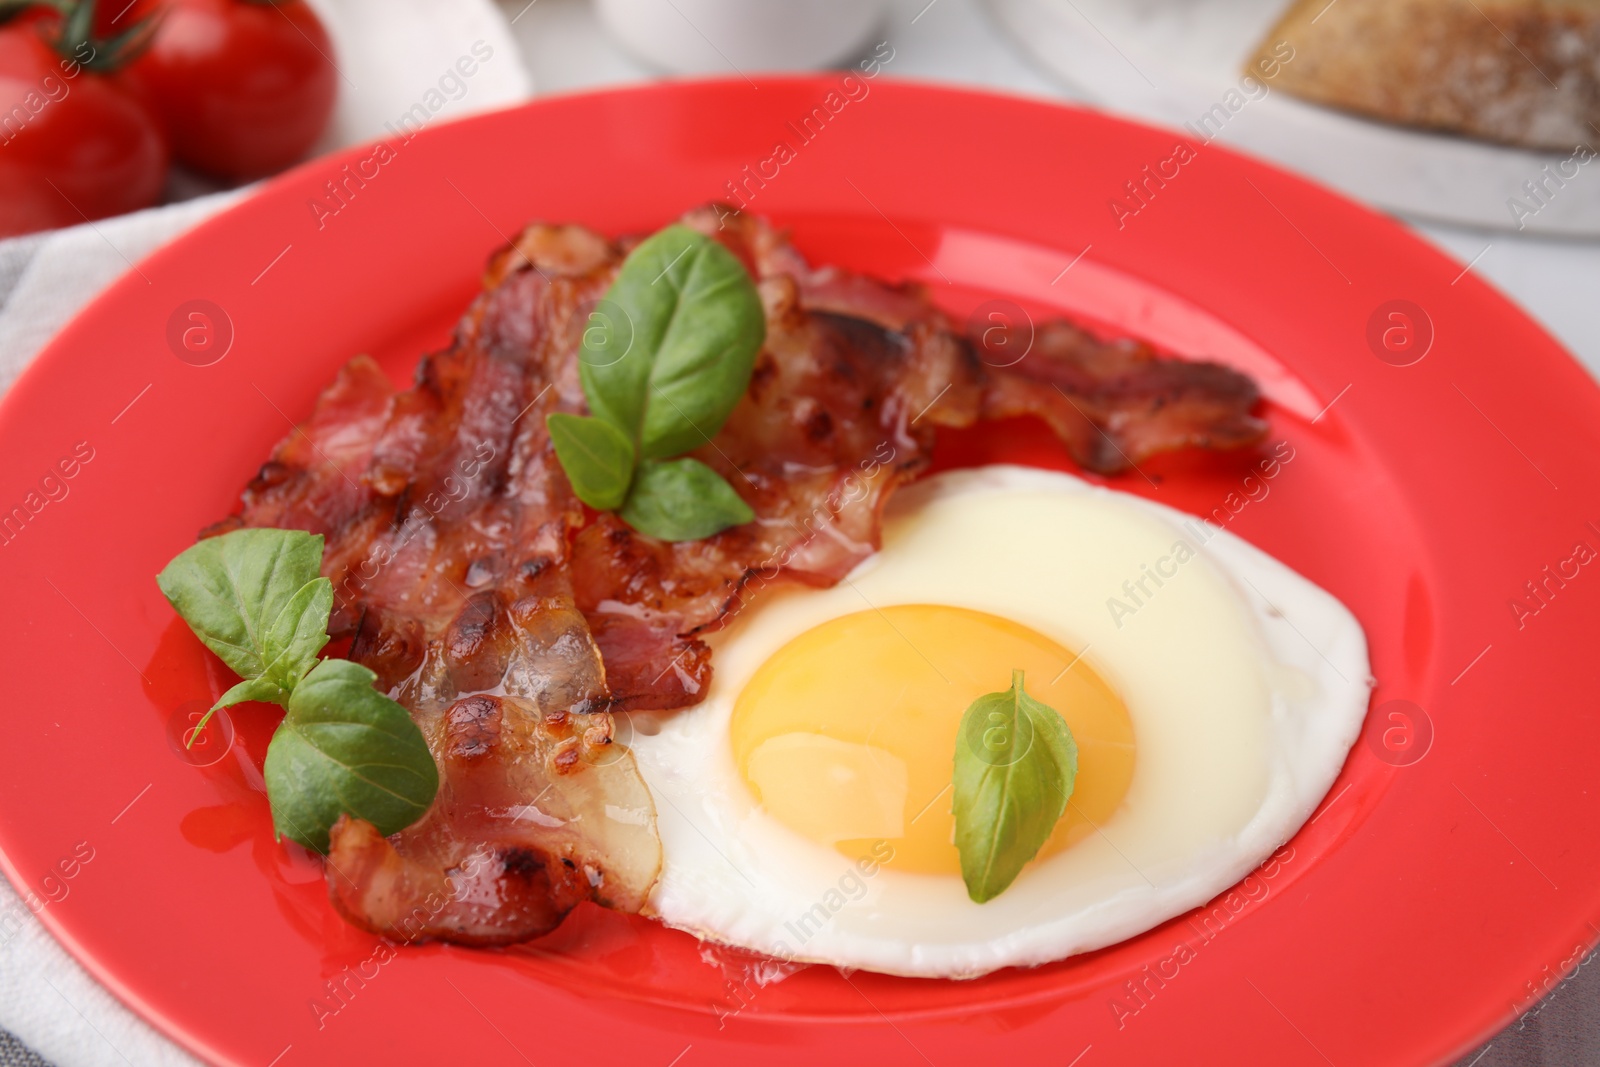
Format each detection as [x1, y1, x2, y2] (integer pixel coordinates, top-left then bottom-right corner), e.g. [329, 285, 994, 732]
[597, 0, 888, 74]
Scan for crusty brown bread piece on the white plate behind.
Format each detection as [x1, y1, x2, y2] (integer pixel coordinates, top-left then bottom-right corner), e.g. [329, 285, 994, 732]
[1246, 0, 1600, 150]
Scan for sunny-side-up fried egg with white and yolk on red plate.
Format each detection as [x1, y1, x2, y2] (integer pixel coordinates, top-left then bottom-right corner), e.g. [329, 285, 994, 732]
[632, 467, 1370, 977]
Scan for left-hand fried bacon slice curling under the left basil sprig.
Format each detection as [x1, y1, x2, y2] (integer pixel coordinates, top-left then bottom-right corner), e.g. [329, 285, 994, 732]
[219, 227, 661, 944]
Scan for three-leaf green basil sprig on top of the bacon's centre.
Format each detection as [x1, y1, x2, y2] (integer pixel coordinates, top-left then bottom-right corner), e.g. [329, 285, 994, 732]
[546, 226, 766, 541]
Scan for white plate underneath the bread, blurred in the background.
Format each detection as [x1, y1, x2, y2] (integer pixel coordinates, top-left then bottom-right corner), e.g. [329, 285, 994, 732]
[990, 0, 1600, 237]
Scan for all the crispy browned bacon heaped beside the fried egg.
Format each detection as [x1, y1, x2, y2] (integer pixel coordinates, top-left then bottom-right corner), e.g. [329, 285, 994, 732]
[211, 206, 1264, 944]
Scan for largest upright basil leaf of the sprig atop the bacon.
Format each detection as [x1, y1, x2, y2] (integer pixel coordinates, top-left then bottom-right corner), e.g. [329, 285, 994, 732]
[582, 226, 766, 466]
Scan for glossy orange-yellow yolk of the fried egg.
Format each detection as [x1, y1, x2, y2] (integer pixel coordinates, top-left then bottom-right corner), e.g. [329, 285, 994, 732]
[731, 605, 1134, 875]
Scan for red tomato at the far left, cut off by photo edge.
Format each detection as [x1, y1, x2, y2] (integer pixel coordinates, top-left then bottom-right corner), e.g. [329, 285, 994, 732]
[0, 21, 166, 235]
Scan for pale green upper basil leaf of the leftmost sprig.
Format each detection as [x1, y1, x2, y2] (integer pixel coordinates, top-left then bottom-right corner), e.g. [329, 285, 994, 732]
[155, 530, 333, 688]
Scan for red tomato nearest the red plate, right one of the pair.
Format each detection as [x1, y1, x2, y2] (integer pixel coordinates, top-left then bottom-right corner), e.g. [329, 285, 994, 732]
[134, 0, 339, 179]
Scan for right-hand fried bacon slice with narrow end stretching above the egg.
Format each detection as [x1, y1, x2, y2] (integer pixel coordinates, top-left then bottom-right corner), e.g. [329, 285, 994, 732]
[573, 206, 1266, 710]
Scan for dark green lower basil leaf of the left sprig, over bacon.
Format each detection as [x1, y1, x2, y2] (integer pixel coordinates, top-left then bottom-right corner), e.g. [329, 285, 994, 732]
[262, 659, 438, 853]
